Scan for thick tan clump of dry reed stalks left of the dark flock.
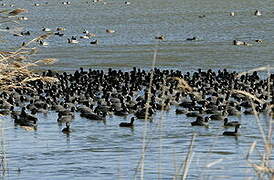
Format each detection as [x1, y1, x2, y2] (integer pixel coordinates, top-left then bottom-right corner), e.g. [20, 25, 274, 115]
[0, 31, 57, 91]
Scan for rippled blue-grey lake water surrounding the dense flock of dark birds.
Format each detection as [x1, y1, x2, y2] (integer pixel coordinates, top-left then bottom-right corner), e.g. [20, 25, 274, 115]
[0, 0, 274, 180]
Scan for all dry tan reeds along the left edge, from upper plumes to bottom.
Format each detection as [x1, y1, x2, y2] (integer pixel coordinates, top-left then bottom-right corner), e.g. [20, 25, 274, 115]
[0, 8, 57, 176]
